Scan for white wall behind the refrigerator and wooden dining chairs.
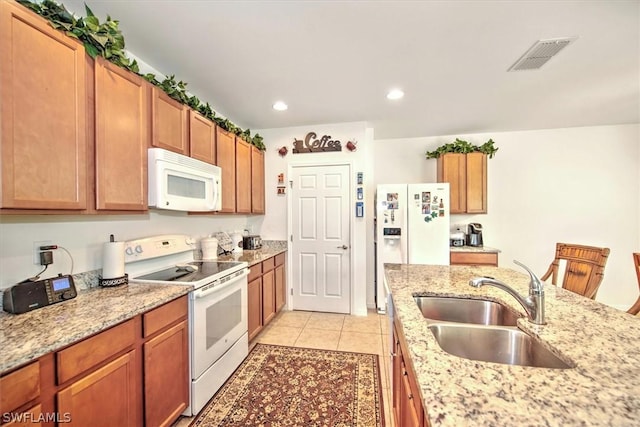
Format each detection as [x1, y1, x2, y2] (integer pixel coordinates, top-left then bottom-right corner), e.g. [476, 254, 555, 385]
[373, 125, 640, 310]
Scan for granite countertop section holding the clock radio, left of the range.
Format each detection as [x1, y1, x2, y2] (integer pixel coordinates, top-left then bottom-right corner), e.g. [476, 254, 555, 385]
[0, 283, 193, 373]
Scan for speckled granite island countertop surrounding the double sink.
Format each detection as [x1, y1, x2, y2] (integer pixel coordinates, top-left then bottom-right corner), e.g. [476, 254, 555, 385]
[385, 264, 640, 427]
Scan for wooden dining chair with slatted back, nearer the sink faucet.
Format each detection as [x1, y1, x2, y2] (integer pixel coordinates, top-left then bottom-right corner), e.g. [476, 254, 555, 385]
[542, 243, 610, 299]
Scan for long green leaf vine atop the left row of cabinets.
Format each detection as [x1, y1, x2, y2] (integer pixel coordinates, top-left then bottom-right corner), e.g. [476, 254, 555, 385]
[16, 0, 266, 151]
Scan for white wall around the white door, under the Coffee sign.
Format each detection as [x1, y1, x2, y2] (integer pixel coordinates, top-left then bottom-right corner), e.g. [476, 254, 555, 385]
[256, 122, 375, 315]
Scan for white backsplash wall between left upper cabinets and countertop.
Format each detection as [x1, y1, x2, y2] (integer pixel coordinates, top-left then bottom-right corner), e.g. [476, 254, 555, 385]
[0, 210, 260, 288]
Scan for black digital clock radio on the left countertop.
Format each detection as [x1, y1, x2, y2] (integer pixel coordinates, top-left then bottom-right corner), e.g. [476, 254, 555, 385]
[2, 274, 78, 314]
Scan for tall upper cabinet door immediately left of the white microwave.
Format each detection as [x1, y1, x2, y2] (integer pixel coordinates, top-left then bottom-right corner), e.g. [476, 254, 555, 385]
[95, 57, 150, 211]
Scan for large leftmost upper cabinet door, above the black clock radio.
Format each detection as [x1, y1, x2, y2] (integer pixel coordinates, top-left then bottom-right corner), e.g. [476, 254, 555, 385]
[0, 1, 87, 210]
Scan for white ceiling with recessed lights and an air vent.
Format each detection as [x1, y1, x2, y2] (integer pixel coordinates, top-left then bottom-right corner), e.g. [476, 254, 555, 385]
[60, 0, 640, 139]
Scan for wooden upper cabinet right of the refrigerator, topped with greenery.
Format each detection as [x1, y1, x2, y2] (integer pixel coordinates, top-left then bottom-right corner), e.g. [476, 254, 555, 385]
[437, 153, 487, 214]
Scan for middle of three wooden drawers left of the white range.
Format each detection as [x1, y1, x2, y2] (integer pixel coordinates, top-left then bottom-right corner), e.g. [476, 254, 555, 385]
[56, 319, 136, 384]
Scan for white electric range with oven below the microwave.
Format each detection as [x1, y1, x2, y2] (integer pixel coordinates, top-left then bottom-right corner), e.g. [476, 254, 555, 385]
[125, 235, 249, 416]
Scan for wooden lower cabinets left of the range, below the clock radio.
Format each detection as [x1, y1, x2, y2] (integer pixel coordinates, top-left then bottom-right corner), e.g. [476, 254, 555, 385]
[0, 295, 190, 427]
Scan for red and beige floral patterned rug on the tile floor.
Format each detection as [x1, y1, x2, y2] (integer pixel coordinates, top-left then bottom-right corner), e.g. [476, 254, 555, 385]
[190, 344, 384, 427]
